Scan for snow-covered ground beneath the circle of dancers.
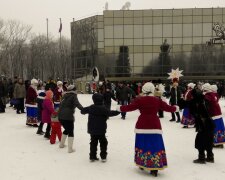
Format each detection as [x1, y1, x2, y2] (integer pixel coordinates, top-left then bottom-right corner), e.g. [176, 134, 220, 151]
[0, 95, 225, 180]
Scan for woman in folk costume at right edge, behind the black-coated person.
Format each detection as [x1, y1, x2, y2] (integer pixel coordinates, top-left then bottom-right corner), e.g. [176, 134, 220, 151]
[206, 85, 225, 148]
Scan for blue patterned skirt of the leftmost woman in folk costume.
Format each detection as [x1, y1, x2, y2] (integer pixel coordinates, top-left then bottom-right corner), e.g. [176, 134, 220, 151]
[26, 104, 38, 125]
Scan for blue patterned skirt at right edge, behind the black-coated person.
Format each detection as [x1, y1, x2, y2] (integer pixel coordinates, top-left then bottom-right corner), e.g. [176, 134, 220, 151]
[212, 117, 225, 145]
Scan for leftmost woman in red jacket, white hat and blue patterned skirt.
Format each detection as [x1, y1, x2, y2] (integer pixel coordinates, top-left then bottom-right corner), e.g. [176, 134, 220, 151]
[26, 79, 38, 127]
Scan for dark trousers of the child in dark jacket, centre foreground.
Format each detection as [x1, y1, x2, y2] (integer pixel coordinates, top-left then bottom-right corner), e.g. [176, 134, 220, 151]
[90, 134, 108, 159]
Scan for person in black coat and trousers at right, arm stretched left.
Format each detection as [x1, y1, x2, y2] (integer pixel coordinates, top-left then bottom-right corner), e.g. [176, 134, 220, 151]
[178, 89, 215, 164]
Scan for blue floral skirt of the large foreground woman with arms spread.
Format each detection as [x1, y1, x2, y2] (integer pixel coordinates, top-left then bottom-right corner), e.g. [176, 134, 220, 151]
[135, 134, 167, 170]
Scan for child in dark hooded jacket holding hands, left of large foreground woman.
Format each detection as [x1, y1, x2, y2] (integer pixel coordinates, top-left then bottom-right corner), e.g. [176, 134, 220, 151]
[81, 93, 120, 162]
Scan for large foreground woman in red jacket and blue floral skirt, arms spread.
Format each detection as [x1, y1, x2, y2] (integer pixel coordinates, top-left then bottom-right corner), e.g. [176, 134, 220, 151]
[117, 82, 178, 176]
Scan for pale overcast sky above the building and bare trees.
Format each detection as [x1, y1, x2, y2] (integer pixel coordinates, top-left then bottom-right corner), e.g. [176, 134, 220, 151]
[0, 0, 225, 37]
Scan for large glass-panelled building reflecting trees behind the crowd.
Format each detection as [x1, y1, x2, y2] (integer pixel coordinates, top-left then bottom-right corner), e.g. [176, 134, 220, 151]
[71, 8, 225, 79]
